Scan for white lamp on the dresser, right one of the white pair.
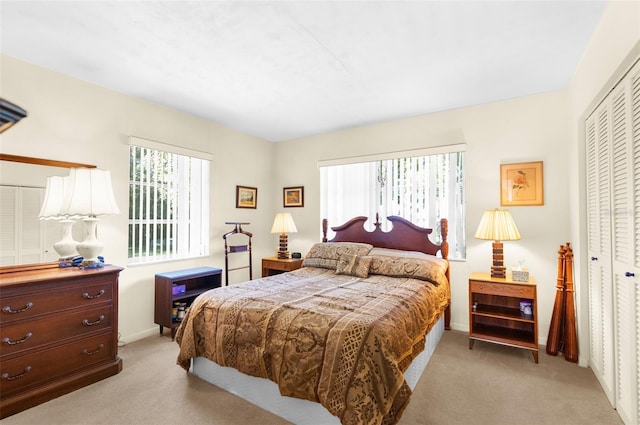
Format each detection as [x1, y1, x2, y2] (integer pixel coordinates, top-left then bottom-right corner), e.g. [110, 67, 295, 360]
[62, 168, 120, 268]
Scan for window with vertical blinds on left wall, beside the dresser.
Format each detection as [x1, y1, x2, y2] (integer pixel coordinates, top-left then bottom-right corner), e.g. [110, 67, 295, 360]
[129, 138, 209, 264]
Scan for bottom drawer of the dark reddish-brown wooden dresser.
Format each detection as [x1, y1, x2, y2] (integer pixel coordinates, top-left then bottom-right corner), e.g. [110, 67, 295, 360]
[0, 333, 114, 398]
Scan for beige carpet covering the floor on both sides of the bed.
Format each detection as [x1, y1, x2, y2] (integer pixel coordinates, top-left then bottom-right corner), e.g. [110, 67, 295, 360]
[0, 331, 622, 425]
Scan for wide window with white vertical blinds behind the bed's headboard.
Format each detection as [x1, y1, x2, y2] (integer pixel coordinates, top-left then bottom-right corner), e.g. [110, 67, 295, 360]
[320, 152, 466, 259]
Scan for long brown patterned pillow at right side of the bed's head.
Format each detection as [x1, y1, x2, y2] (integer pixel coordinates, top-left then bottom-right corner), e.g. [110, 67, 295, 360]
[369, 255, 446, 285]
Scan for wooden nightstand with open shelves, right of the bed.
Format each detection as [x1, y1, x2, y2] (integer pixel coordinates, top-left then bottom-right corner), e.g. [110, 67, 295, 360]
[469, 272, 538, 363]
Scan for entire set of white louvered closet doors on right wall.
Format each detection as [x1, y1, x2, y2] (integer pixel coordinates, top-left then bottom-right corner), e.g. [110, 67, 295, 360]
[586, 57, 640, 424]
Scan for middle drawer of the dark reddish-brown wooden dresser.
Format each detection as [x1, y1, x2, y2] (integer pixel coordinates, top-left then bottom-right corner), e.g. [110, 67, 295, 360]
[0, 305, 113, 359]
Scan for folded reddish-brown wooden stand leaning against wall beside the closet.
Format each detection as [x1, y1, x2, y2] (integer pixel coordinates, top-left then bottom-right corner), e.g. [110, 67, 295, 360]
[547, 242, 578, 363]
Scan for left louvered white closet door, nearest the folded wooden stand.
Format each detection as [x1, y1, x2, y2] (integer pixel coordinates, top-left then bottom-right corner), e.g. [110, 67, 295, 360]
[586, 97, 615, 404]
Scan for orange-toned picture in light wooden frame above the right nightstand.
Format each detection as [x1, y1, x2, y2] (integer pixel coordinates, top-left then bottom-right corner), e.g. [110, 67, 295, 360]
[500, 161, 544, 206]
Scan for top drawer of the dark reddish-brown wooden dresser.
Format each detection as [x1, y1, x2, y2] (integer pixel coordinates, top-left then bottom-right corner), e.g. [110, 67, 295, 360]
[0, 278, 113, 324]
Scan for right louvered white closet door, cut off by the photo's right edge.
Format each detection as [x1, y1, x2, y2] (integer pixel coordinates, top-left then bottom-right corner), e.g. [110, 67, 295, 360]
[609, 59, 640, 424]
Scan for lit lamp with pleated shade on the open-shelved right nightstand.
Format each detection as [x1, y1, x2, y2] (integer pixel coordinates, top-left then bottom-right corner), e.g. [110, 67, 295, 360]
[475, 208, 520, 278]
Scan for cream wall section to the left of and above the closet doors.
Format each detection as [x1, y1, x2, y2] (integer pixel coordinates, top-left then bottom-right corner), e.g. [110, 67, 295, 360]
[567, 1, 640, 365]
